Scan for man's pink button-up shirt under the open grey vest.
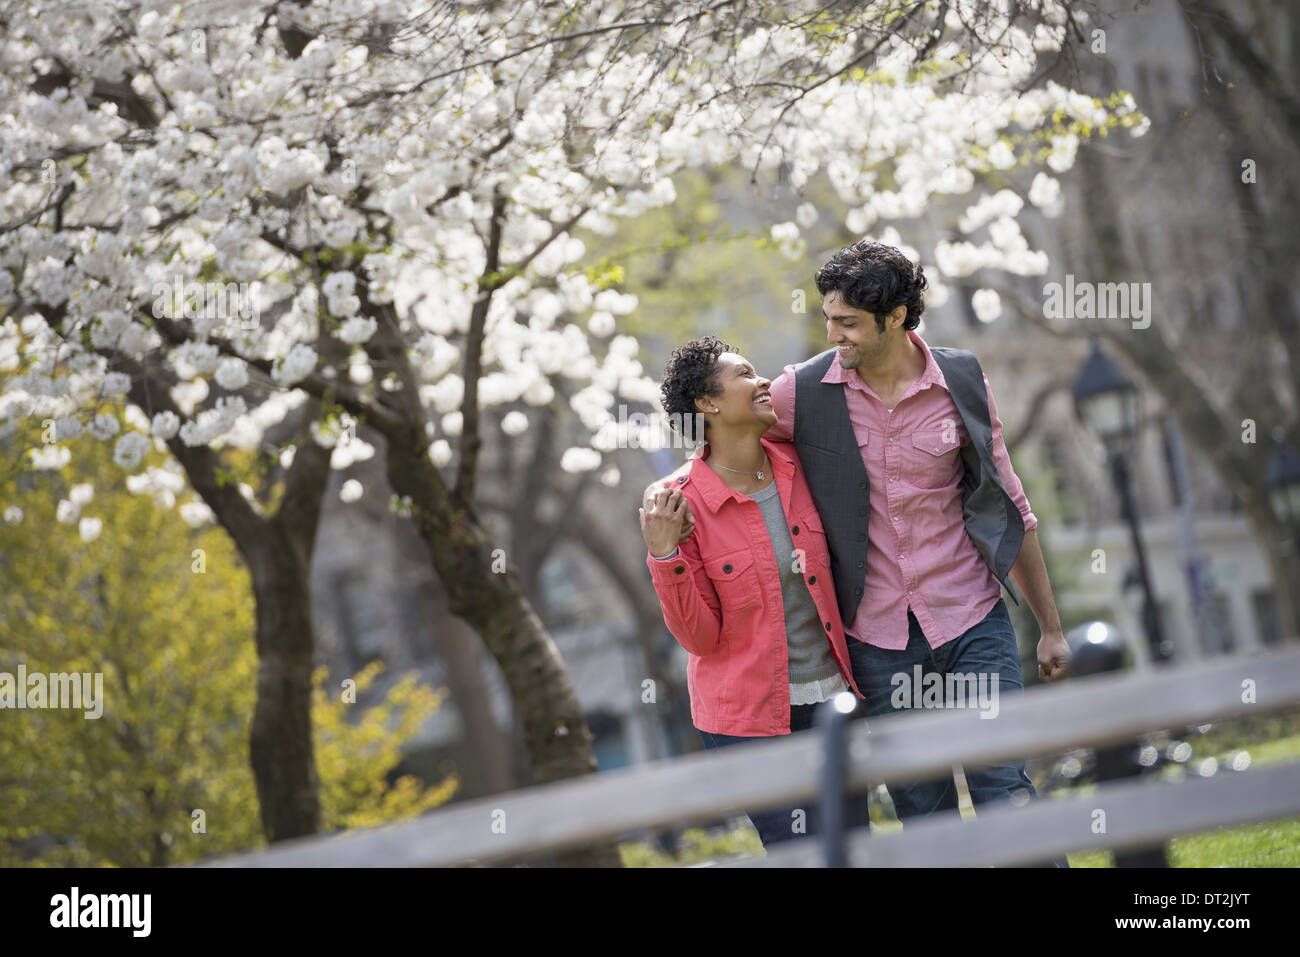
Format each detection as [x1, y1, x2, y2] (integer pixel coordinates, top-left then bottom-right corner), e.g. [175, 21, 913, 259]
[767, 330, 1037, 650]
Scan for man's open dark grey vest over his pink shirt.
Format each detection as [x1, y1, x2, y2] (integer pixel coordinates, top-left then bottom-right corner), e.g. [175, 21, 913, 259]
[794, 346, 1024, 628]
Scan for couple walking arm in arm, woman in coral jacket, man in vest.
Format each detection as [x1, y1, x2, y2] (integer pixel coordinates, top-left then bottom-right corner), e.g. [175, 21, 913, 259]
[641, 241, 1070, 845]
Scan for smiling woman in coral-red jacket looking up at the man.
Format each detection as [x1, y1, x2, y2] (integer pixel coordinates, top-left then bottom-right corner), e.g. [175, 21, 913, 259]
[641, 335, 865, 846]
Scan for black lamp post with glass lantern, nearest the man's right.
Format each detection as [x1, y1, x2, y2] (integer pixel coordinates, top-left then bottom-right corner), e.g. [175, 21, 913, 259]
[1074, 339, 1171, 664]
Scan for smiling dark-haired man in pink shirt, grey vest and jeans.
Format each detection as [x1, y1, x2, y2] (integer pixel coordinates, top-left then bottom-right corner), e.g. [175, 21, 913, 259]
[646, 241, 1070, 858]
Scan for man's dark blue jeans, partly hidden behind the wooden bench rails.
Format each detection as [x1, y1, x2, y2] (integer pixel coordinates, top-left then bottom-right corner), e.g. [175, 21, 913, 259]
[849, 598, 1069, 867]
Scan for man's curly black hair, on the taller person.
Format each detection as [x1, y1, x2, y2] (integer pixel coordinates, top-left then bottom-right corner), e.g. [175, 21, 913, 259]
[816, 239, 927, 332]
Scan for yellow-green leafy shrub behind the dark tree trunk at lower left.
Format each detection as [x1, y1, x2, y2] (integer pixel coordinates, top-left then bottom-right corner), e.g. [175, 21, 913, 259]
[0, 418, 458, 866]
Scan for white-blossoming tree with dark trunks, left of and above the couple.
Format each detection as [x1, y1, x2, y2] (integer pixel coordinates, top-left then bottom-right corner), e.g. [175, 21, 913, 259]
[0, 0, 1139, 858]
